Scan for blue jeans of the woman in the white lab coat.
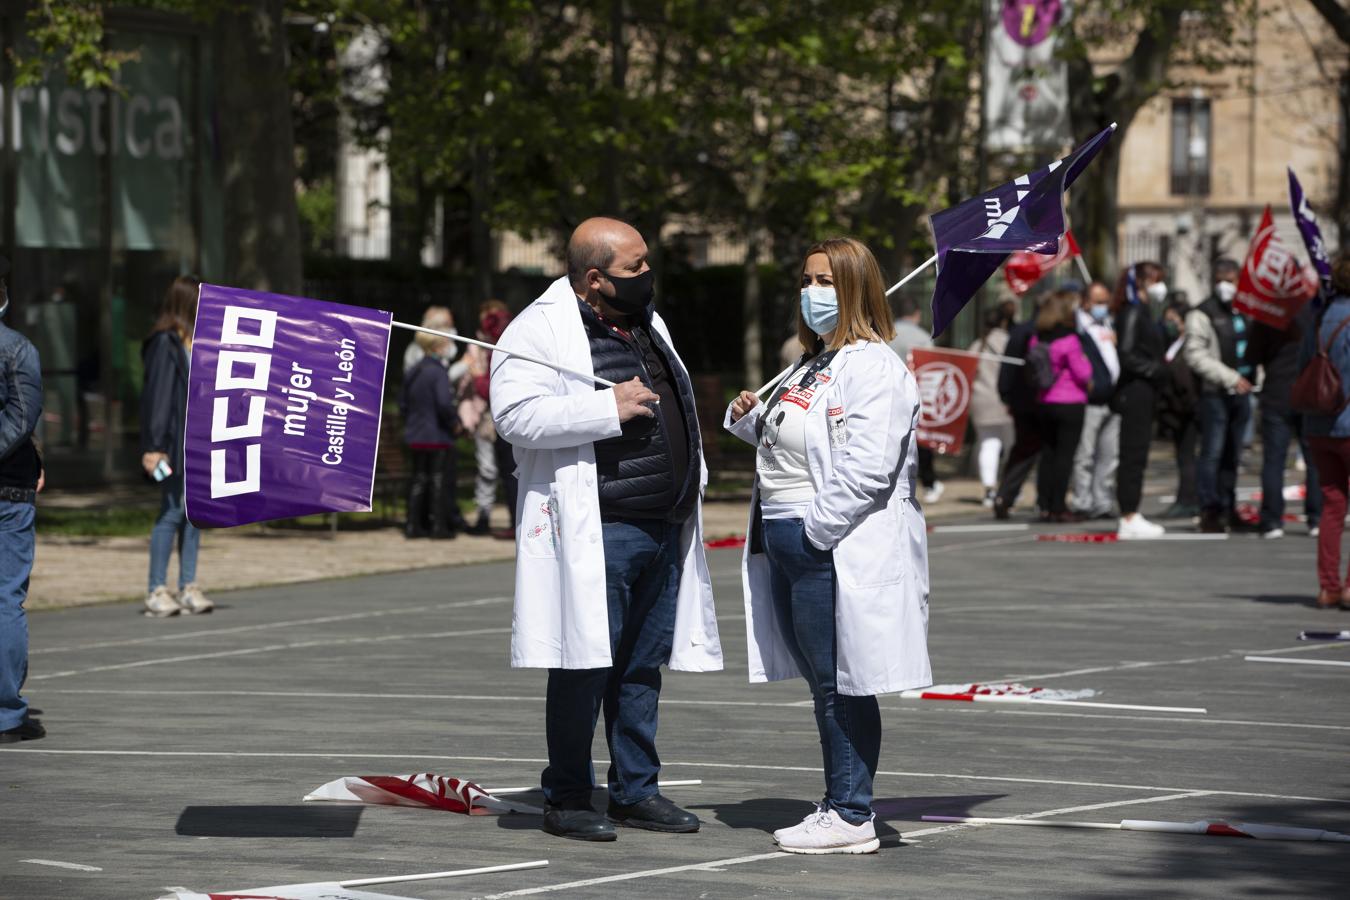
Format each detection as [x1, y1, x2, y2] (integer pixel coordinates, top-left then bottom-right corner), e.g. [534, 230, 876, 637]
[764, 518, 882, 824]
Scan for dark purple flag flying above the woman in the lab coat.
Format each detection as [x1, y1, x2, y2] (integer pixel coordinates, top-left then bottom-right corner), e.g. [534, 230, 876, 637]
[929, 124, 1115, 336]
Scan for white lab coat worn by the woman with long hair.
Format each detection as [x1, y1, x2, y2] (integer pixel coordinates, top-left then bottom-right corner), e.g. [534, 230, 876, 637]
[724, 341, 933, 696]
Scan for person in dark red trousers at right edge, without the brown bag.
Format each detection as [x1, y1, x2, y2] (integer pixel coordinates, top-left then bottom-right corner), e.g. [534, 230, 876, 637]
[1297, 250, 1350, 610]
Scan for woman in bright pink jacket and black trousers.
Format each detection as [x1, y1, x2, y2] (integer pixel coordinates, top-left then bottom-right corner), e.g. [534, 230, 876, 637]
[1027, 290, 1092, 522]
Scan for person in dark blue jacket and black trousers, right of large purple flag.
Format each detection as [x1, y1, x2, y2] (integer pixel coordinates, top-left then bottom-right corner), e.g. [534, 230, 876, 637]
[398, 332, 467, 538]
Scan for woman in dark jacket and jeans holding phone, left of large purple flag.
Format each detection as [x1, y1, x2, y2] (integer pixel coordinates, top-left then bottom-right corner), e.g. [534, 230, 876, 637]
[140, 275, 215, 617]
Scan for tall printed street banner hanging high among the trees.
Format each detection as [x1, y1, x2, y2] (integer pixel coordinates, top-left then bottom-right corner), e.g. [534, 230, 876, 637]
[984, 0, 1071, 152]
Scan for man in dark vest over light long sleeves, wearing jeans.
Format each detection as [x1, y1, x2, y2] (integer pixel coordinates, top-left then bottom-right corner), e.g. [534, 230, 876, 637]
[1181, 259, 1256, 534]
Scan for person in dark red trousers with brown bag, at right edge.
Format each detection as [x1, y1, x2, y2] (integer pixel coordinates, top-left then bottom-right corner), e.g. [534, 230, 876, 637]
[1292, 250, 1350, 610]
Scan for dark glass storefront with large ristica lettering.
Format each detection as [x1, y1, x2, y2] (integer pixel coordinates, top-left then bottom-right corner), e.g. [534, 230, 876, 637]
[0, 13, 221, 486]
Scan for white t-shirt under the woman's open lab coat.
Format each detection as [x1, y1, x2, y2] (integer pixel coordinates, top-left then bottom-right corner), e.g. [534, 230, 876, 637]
[755, 366, 824, 518]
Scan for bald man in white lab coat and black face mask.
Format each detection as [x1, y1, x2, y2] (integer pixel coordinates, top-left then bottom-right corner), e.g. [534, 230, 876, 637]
[490, 219, 722, 841]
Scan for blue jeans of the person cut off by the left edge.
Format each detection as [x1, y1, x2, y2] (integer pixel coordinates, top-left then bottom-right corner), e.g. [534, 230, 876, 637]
[0, 501, 35, 731]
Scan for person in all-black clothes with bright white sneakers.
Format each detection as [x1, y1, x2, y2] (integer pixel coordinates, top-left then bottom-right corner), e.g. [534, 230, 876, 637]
[1111, 262, 1168, 540]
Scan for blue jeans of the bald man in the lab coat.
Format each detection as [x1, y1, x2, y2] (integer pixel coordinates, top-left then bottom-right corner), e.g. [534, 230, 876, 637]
[541, 519, 683, 810]
